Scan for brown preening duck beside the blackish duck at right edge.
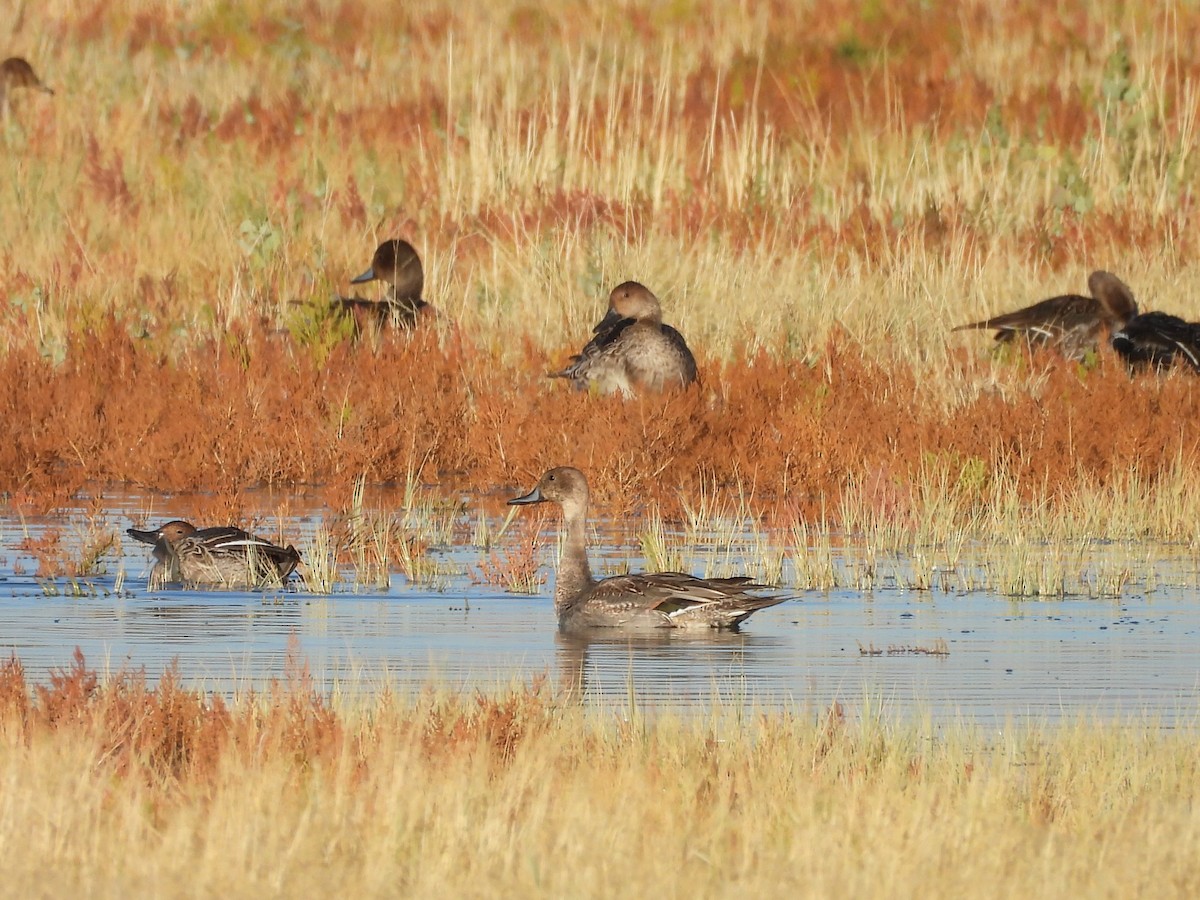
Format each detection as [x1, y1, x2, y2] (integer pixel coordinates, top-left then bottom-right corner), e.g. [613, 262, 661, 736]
[954, 269, 1138, 362]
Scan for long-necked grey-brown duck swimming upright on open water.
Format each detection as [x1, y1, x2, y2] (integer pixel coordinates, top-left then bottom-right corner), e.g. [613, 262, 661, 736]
[509, 466, 790, 631]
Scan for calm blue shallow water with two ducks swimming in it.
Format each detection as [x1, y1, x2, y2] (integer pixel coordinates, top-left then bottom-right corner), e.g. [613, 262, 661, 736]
[0, 498, 1200, 725]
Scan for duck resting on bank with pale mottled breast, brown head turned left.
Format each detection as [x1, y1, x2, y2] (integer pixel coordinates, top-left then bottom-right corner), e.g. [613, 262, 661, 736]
[548, 281, 697, 397]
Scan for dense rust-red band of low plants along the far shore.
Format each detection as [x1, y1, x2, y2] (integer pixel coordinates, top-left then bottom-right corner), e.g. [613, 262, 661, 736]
[0, 322, 1200, 517]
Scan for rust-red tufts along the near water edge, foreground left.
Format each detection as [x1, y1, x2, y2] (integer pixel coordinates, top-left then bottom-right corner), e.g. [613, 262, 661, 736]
[0, 638, 554, 787]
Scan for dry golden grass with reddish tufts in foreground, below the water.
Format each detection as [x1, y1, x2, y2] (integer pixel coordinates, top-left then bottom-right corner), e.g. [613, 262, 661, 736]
[0, 658, 1200, 898]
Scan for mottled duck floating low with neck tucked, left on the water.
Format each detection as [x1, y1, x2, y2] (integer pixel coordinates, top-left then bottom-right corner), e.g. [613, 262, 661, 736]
[126, 518, 300, 589]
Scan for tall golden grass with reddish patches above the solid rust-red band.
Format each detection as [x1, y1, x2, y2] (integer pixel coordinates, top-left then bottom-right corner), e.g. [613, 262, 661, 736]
[7, 0, 1200, 355]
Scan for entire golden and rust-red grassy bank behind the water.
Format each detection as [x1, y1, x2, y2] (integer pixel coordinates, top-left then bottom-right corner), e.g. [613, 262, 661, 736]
[0, 0, 1200, 521]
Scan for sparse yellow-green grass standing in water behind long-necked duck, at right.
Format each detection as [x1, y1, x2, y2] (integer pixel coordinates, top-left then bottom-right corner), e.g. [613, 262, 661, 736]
[516, 462, 1200, 599]
